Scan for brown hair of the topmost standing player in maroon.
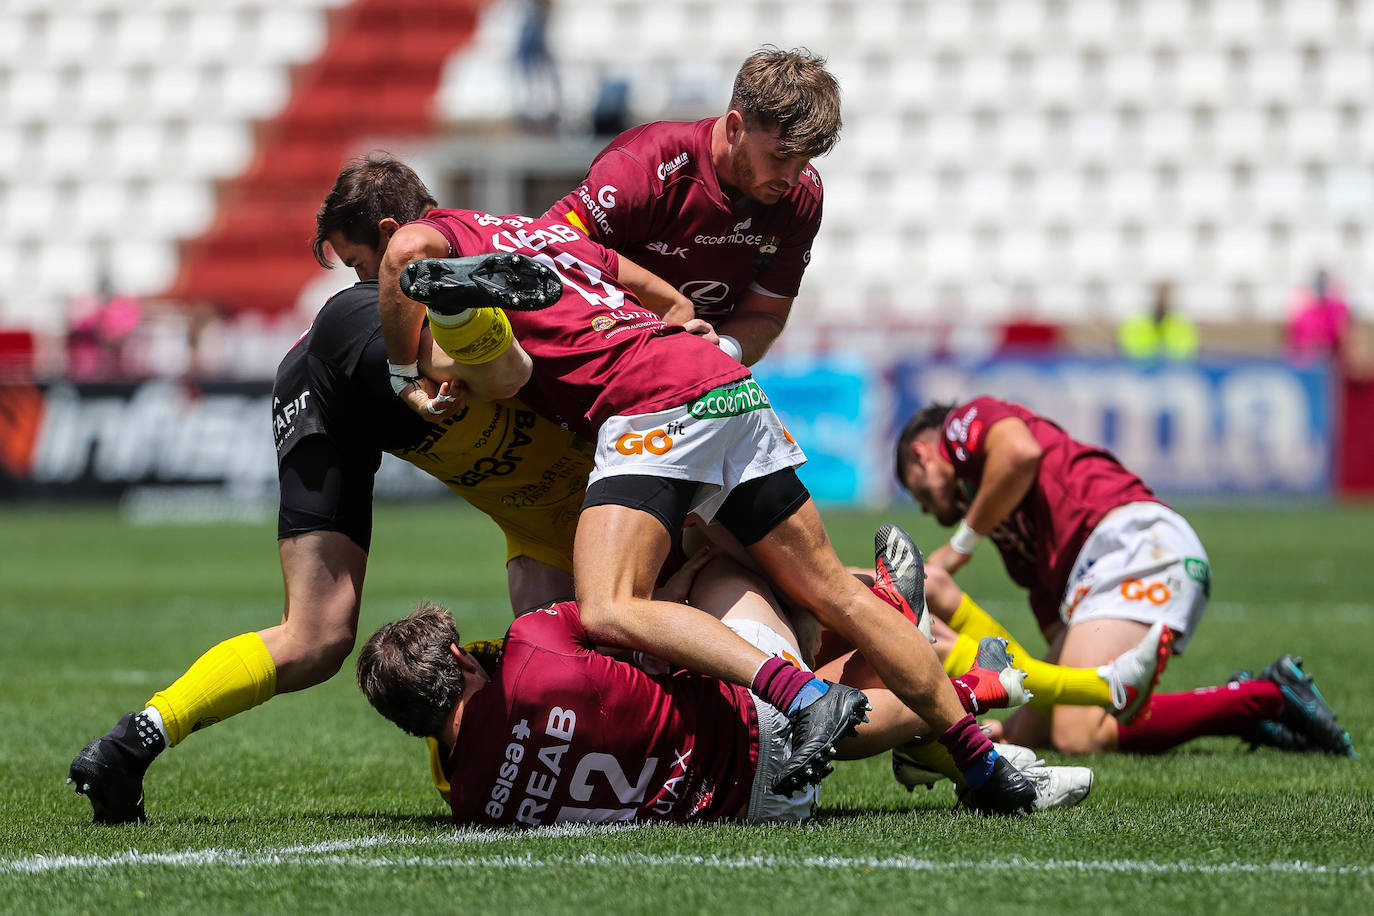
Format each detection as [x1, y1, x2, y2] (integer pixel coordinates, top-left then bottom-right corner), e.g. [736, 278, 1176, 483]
[730, 45, 841, 158]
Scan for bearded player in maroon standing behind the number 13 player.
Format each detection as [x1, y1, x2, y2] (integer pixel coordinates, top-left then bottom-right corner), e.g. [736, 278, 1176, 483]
[545, 48, 841, 365]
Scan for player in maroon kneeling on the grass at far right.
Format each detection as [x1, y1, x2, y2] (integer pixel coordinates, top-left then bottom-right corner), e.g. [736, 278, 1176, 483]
[896, 397, 1355, 755]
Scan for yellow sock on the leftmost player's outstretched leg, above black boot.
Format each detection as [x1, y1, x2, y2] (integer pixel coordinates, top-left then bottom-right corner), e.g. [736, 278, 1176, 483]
[147, 633, 276, 747]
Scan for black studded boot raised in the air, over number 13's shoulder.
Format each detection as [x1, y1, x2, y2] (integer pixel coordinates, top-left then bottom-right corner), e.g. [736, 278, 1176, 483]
[401, 254, 563, 316]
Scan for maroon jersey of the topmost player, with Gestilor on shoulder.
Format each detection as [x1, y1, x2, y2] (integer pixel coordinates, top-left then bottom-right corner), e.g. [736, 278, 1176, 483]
[545, 118, 822, 323]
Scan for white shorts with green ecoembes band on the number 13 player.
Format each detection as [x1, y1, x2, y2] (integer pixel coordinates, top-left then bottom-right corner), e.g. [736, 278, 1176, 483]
[587, 378, 807, 522]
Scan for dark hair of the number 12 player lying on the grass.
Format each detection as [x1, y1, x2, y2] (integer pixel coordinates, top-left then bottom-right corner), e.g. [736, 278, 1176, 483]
[356, 602, 464, 737]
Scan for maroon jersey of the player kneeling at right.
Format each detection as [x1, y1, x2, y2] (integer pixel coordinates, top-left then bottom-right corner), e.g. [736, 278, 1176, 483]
[940, 397, 1161, 630]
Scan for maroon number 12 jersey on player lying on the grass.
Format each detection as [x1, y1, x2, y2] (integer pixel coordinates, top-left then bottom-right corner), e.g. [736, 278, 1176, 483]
[449, 602, 758, 827]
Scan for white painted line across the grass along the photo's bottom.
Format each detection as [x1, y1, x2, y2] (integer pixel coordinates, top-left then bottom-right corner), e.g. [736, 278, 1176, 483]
[0, 828, 1374, 876]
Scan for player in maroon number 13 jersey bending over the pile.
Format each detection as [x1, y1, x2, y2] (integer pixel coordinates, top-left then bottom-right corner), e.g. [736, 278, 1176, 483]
[381, 164, 1033, 810]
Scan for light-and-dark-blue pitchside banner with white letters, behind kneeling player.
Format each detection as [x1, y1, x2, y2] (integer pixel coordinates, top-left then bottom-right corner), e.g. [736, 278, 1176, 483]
[758, 358, 1334, 505]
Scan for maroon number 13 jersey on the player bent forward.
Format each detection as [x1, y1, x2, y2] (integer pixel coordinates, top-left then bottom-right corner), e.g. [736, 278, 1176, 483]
[422, 210, 749, 442]
